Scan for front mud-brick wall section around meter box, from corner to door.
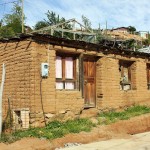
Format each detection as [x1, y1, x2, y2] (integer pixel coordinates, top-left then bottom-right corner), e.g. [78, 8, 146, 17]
[32, 43, 83, 114]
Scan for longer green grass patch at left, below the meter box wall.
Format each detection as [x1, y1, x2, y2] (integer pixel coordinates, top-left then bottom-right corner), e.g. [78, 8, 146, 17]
[0, 119, 95, 143]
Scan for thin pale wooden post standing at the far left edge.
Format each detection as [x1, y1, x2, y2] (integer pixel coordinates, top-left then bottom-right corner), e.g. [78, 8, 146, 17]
[0, 64, 5, 137]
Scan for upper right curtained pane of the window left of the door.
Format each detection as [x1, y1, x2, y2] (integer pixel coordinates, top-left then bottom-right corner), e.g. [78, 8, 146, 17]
[65, 57, 73, 79]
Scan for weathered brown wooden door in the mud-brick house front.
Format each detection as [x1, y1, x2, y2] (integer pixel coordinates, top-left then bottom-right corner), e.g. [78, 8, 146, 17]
[83, 58, 96, 107]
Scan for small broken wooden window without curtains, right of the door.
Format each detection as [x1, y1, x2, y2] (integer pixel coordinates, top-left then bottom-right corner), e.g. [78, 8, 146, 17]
[119, 61, 132, 90]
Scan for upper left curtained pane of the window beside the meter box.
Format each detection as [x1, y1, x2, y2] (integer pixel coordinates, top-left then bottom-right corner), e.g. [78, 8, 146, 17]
[56, 56, 62, 78]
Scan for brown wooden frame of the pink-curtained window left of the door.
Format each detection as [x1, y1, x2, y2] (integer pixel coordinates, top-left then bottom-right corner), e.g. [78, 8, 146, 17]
[55, 54, 77, 90]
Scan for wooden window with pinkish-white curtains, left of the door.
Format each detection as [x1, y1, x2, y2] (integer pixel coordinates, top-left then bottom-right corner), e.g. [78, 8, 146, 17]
[56, 56, 76, 90]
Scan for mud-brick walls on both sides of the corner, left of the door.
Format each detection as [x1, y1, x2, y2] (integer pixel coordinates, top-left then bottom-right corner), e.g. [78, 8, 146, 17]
[0, 39, 84, 126]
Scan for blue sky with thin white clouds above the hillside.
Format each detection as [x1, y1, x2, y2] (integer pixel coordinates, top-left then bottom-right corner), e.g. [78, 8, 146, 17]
[0, 0, 150, 31]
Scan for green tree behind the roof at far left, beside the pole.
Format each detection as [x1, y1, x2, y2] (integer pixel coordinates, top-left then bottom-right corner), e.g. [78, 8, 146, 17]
[0, 1, 22, 38]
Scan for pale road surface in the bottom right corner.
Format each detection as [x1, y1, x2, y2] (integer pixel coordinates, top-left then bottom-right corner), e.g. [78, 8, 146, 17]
[61, 132, 150, 150]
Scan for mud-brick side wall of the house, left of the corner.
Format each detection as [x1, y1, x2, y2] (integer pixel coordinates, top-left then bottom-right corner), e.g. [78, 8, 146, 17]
[0, 40, 33, 118]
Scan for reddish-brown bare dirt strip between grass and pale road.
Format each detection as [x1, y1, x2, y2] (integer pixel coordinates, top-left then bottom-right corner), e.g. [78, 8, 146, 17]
[0, 114, 150, 150]
